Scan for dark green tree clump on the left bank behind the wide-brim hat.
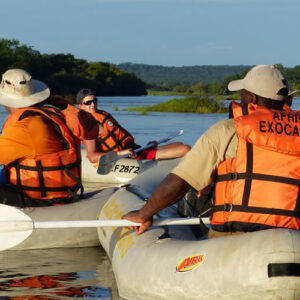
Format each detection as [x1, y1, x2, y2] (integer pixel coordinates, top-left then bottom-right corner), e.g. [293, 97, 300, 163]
[0, 39, 147, 100]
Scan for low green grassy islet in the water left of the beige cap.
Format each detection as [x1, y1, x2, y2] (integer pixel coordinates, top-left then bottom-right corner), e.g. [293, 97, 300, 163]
[126, 97, 228, 114]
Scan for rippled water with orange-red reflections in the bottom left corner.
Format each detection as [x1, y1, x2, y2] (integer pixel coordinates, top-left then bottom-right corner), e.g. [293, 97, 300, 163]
[0, 247, 118, 299]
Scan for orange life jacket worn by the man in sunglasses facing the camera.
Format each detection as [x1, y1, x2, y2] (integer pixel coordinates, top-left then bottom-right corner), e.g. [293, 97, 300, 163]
[92, 110, 134, 152]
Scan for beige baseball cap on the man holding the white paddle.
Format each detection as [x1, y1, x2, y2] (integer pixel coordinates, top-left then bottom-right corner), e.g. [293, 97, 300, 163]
[228, 65, 298, 101]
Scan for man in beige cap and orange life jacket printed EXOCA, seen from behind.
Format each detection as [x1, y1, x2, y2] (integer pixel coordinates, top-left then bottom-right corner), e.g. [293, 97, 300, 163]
[123, 65, 300, 237]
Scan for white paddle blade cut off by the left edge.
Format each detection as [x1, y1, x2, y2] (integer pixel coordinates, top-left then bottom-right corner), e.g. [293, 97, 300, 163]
[0, 204, 33, 251]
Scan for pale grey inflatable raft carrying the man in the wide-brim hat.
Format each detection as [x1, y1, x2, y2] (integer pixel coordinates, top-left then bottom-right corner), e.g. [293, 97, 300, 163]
[9, 188, 116, 250]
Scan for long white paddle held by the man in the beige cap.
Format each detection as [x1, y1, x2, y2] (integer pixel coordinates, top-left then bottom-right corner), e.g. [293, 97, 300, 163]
[0, 204, 209, 251]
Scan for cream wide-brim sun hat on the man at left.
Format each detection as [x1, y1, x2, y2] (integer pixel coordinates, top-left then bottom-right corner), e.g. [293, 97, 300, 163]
[0, 69, 50, 108]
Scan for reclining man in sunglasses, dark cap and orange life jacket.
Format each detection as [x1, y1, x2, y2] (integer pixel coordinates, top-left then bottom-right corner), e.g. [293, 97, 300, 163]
[76, 89, 190, 159]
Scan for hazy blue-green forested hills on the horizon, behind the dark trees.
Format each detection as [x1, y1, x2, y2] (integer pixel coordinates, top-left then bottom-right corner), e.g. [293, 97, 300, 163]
[116, 63, 252, 84]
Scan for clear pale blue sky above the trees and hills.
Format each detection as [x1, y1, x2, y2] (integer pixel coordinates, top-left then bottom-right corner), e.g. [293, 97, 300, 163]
[0, 0, 300, 67]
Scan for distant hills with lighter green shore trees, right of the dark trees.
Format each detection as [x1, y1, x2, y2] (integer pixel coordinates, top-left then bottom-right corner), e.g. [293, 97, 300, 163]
[118, 63, 300, 96]
